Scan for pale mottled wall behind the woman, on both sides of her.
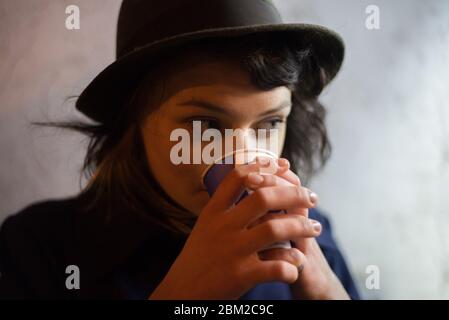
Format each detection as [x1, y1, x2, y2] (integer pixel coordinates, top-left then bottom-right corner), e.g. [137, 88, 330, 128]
[0, 0, 449, 298]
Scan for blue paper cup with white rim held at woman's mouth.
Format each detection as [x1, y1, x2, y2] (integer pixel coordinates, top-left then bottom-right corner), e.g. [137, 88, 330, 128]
[202, 149, 292, 251]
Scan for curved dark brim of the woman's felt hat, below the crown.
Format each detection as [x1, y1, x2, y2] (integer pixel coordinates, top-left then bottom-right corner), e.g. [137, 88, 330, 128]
[76, 23, 345, 123]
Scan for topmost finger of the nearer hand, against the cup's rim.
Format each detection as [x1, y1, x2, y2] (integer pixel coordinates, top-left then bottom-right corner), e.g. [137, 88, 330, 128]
[206, 163, 260, 212]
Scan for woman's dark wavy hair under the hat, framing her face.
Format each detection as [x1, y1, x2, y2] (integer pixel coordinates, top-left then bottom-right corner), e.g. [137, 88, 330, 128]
[34, 33, 331, 233]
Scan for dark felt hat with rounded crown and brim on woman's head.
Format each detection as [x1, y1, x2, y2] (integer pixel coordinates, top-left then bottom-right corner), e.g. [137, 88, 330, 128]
[76, 0, 344, 123]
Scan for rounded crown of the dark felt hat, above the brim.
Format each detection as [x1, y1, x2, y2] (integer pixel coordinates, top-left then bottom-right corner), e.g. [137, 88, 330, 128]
[116, 0, 282, 58]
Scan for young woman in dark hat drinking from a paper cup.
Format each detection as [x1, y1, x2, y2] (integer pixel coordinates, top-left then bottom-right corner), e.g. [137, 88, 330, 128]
[0, 0, 358, 299]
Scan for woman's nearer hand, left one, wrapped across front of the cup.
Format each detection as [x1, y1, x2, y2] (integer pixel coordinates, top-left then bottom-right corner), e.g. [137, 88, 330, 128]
[149, 161, 317, 299]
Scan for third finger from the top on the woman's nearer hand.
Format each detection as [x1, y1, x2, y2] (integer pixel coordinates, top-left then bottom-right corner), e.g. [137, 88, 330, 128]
[245, 214, 322, 252]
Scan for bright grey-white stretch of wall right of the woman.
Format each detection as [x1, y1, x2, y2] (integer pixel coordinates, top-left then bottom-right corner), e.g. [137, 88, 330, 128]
[278, 0, 449, 299]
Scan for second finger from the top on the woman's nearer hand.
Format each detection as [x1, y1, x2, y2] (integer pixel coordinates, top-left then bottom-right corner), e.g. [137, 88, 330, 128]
[230, 186, 315, 228]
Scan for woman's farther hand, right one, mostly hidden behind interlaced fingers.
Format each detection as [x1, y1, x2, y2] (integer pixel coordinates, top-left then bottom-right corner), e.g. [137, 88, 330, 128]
[247, 159, 349, 299]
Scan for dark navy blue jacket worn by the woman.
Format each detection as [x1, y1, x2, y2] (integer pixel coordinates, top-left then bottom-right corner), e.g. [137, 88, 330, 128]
[0, 192, 359, 300]
